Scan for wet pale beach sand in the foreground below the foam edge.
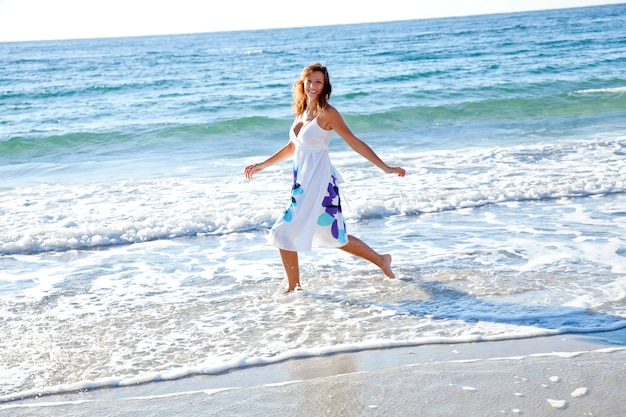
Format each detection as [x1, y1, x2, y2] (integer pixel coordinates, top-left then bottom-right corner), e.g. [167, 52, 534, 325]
[0, 329, 626, 417]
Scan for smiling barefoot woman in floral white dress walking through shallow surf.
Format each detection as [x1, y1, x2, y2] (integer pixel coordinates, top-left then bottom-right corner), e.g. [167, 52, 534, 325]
[244, 63, 405, 292]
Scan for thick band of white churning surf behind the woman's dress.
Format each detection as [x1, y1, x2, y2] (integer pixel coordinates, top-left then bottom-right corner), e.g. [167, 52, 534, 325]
[0, 136, 626, 255]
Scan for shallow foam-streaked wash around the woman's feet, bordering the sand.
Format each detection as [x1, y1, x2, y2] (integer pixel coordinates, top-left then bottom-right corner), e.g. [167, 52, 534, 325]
[6, 183, 626, 404]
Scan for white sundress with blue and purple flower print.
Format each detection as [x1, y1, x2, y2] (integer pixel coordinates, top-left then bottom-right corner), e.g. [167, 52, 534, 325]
[269, 117, 348, 252]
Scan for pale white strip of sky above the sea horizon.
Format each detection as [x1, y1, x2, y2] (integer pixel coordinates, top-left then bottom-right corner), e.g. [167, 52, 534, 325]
[0, 0, 624, 42]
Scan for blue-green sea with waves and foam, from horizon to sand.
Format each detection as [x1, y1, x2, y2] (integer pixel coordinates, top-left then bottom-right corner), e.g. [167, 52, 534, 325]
[0, 4, 626, 407]
